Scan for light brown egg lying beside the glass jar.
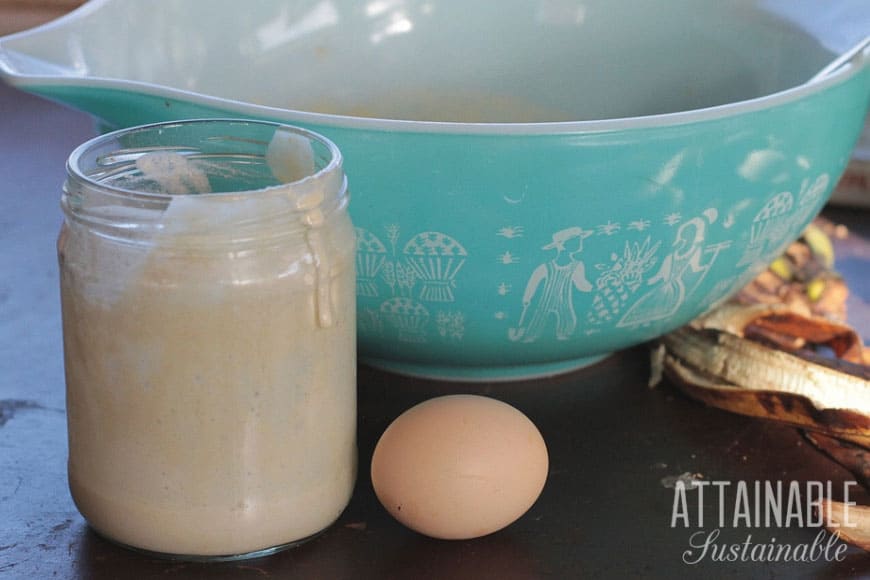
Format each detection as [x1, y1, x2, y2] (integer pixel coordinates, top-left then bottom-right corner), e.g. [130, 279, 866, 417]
[371, 395, 549, 539]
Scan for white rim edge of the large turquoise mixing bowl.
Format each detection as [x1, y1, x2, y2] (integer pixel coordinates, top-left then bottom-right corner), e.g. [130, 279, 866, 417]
[0, 0, 870, 135]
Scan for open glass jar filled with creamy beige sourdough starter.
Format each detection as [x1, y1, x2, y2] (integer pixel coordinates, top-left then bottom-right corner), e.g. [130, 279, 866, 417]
[58, 120, 356, 559]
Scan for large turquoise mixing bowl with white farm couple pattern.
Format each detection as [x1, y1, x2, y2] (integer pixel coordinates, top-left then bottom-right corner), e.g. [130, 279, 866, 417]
[0, 0, 870, 379]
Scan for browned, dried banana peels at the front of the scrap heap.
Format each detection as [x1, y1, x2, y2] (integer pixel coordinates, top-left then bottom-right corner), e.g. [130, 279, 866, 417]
[653, 307, 870, 551]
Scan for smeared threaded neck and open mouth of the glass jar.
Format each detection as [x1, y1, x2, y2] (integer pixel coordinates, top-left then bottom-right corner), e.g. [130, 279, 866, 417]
[62, 119, 347, 243]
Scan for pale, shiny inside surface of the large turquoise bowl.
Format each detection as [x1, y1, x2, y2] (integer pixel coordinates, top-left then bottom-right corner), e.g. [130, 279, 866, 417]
[4, 0, 870, 122]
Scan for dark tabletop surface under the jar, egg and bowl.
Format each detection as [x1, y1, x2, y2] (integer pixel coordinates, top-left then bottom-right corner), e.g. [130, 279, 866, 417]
[0, 85, 870, 580]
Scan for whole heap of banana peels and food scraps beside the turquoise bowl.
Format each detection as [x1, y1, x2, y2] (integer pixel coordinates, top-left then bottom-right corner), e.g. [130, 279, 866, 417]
[651, 226, 870, 551]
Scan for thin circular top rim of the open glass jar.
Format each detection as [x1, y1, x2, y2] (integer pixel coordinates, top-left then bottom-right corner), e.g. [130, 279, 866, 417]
[66, 117, 346, 202]
